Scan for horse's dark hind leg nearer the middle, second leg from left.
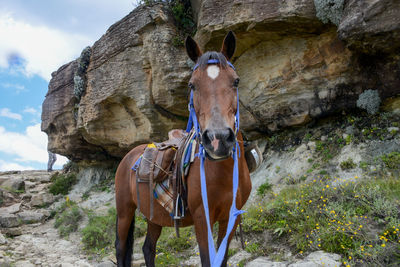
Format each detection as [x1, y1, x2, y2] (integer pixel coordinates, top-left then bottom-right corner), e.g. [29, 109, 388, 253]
[143, 220, 162, 267]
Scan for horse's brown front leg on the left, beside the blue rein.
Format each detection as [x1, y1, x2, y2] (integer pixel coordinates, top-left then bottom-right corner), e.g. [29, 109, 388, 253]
[192, 206, 212, 267]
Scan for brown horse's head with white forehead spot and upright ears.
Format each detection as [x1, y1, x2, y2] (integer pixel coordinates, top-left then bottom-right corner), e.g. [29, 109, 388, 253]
[186, 32, 239, 160]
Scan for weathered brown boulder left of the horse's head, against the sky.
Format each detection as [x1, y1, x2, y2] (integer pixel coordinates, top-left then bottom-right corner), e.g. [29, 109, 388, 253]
[42, 5, 190, 160]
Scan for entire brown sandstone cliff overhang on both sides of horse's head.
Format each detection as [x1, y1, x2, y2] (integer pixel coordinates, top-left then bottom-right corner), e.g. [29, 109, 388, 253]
[42, 0, 400, 161]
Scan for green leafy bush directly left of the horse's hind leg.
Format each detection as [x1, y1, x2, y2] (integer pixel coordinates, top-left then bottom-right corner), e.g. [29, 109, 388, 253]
[82, 208, 117, 253]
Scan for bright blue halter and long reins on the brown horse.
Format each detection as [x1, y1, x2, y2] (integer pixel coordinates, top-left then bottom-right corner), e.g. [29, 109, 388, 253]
[186, 59, 245, 267]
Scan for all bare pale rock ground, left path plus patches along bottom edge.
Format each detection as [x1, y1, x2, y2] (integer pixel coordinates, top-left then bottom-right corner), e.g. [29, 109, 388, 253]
[0, 171, 340, 267]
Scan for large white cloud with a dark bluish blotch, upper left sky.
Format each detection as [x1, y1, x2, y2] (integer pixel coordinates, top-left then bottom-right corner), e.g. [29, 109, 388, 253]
[0, 13, 92, 80]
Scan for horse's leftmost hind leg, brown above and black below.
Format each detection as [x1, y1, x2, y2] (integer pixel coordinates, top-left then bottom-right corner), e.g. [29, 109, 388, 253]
[115, 207, 136, 267]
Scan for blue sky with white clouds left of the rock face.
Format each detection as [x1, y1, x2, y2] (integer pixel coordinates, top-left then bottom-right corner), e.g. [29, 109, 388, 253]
[0, 0, 137, 171]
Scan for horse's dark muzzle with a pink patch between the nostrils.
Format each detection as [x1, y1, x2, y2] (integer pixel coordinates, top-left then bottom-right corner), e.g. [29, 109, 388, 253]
[201, 127, 236, 160]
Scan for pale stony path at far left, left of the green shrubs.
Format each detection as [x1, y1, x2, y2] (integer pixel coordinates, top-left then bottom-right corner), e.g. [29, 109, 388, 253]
[0, 171, 98, 267]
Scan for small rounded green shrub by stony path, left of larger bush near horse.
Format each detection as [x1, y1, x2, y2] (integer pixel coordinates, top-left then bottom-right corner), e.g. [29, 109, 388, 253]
[54, 200, 82, 237]
